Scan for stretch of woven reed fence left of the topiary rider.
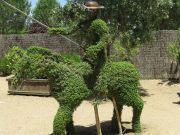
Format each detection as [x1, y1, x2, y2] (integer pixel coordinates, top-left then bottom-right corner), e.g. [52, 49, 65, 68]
[0, 34, 82, 57]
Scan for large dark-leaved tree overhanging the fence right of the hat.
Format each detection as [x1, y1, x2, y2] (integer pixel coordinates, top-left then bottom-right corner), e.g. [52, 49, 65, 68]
[77, 0, 173, 46]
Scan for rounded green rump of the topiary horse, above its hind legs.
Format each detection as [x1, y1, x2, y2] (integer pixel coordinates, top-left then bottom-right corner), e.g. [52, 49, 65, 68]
[95, 62, 140, 95]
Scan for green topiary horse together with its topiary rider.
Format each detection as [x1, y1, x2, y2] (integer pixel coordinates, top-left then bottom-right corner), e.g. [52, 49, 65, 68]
[52, 19, 143, 135]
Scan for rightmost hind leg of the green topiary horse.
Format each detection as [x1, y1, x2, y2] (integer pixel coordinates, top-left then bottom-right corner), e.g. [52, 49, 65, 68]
[132, 97, 144, 133]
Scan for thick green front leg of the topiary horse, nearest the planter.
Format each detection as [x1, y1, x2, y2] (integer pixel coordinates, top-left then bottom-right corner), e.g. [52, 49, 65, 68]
[53, 107, 72, 135]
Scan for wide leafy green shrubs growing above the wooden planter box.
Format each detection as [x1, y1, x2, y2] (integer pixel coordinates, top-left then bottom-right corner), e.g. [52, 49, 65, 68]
[10, 46, 91, 86]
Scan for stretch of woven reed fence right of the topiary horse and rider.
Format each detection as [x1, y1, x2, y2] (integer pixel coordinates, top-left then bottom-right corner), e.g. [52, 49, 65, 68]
[134, 30, 178, 79]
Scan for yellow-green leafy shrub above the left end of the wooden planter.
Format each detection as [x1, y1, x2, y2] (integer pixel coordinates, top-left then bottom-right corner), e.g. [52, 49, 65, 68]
[5, 46, 24, 72]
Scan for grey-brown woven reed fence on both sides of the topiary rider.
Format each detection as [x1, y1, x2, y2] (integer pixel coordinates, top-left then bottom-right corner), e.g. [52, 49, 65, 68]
[0, 31, 177, 79]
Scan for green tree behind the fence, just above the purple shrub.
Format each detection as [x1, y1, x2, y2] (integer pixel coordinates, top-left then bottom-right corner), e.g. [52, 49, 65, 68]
[33, 0, 61, 26]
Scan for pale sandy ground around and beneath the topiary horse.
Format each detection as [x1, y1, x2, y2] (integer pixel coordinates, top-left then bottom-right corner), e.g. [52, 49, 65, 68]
[0, 78, 180, 135]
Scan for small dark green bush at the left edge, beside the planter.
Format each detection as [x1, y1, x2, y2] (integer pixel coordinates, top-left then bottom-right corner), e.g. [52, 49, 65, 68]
[0, 57, 10, 76]
